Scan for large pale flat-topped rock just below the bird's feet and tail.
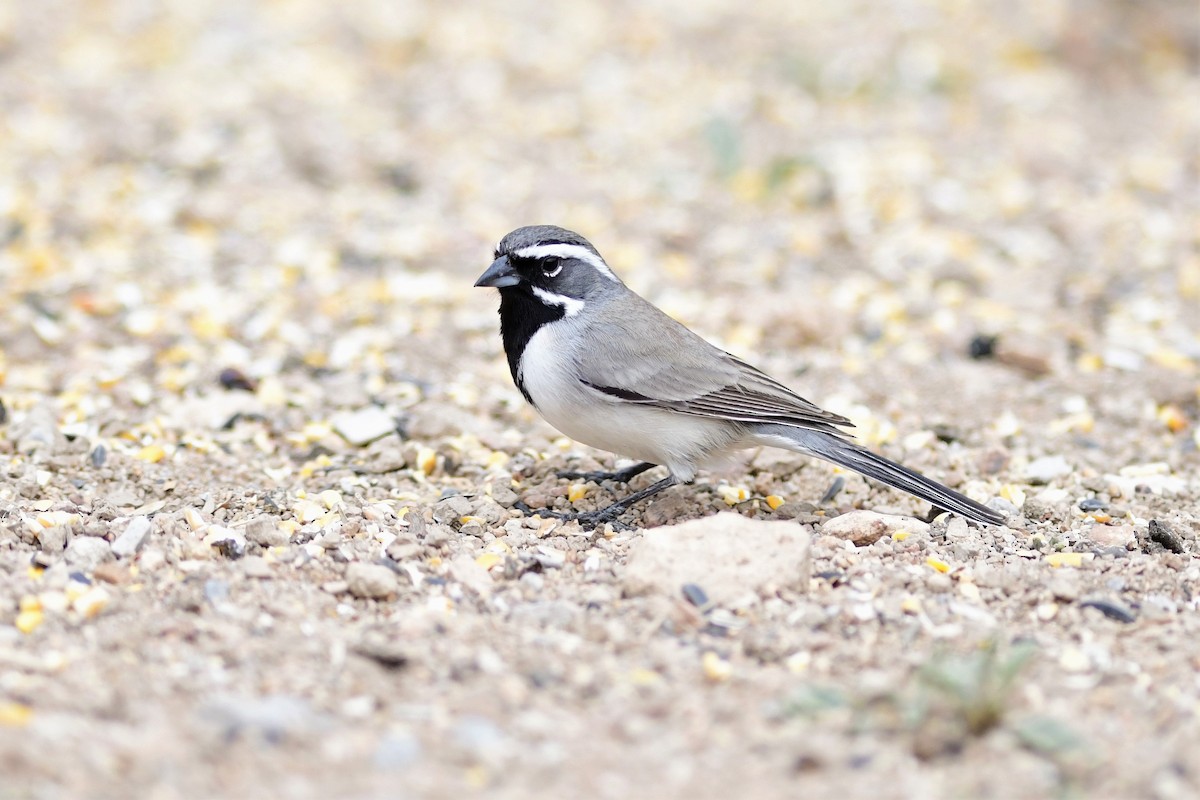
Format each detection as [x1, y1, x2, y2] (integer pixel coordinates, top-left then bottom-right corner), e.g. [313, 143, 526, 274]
[623, 511, 811, 606]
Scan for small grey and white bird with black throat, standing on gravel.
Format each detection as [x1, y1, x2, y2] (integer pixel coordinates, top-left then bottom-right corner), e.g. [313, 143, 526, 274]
[475, 225, 1004, 528]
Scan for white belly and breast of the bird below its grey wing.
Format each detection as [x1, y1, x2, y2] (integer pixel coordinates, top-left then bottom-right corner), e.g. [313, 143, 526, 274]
[521, 323, 737, 481]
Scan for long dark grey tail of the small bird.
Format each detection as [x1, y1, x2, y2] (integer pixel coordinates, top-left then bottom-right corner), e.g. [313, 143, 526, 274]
[760, 425, 1004, 525]
